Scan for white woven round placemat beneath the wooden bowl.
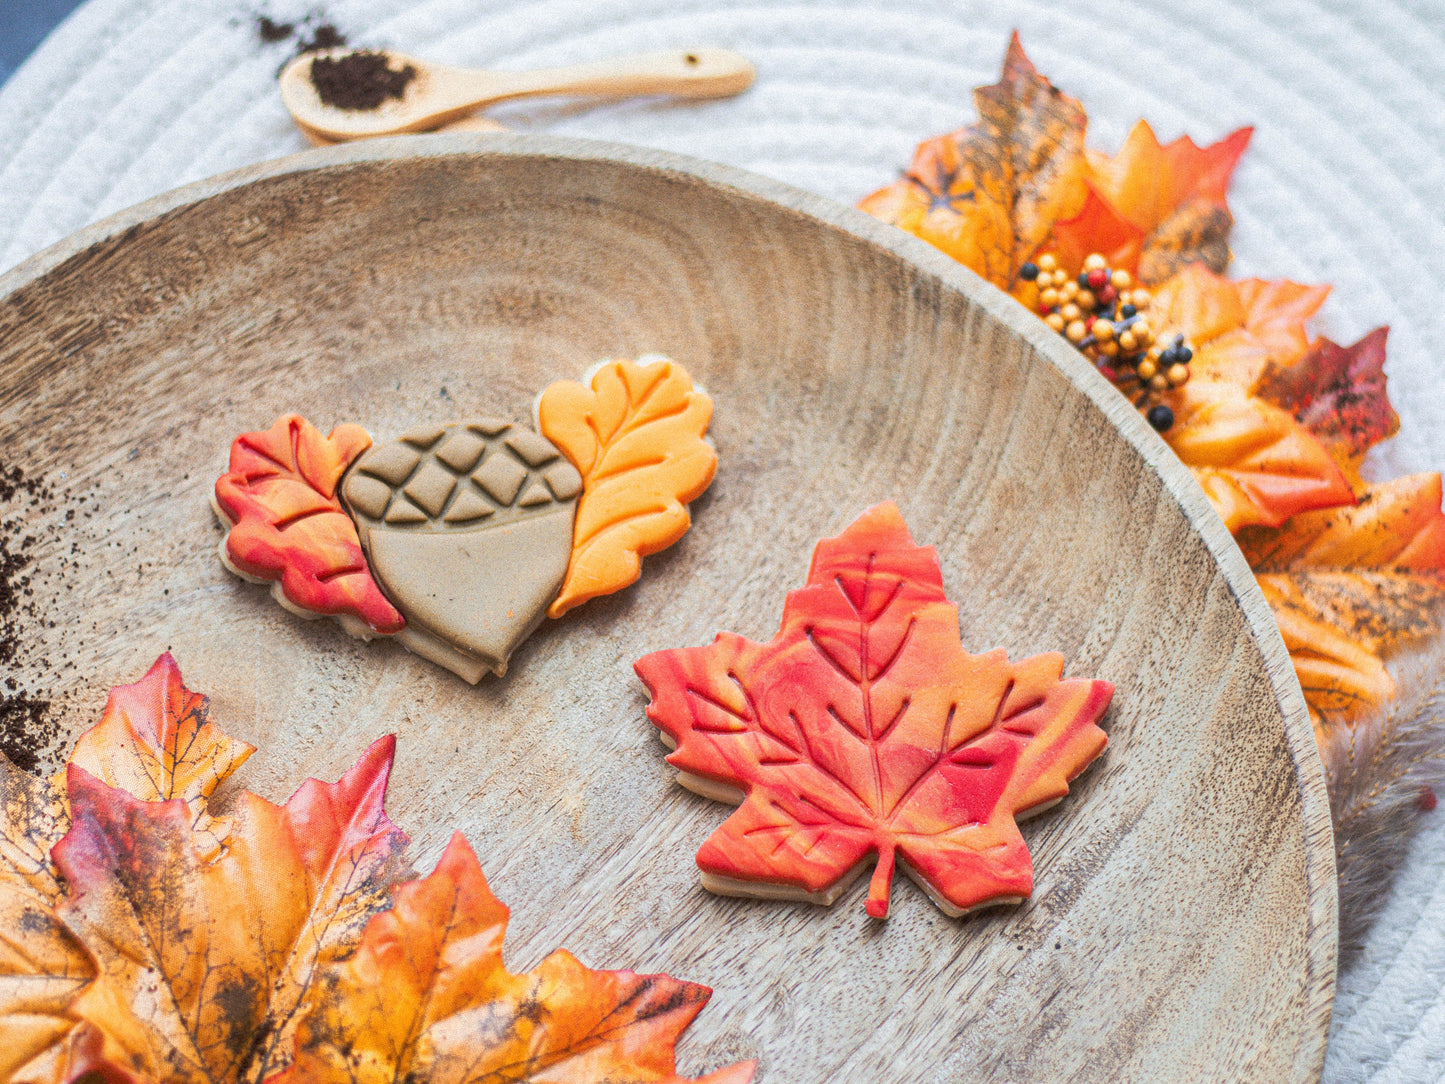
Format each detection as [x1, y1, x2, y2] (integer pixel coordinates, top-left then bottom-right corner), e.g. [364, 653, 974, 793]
[0, 0, 1445, 1083]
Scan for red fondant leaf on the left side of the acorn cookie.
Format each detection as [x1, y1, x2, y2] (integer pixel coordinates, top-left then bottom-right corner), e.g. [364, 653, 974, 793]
[215, 415, 405, 636]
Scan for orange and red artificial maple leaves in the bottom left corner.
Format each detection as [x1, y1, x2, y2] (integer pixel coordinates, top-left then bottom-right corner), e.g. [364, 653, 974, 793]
[0, 656, 753, 1084]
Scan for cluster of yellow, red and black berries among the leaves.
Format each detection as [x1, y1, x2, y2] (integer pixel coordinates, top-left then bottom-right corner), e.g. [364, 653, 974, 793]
[1019, 253, 1194, 393]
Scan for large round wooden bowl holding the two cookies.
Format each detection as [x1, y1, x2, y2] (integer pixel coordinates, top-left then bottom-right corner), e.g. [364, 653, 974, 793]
[0, 136, 1335, 1084]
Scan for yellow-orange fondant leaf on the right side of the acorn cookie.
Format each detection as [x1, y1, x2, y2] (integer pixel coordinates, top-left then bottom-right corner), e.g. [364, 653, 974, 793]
[538, 358, 718, 617]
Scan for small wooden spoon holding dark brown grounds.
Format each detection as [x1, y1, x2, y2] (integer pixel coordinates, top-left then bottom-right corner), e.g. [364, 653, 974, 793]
[280, 49, 753, 142]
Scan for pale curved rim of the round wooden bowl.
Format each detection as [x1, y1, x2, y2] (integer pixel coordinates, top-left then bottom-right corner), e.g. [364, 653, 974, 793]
[0, 134, 1338, 1077]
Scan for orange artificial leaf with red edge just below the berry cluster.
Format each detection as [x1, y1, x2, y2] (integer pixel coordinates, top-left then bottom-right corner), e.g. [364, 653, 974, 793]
[1165, 383, 1354, 530]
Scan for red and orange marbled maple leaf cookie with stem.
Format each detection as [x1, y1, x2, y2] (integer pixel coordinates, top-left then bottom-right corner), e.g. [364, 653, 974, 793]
[636, 503, 1113, 918]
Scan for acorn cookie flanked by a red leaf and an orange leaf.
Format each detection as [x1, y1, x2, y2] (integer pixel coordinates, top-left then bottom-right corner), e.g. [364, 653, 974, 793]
[212, 356, 717, 682]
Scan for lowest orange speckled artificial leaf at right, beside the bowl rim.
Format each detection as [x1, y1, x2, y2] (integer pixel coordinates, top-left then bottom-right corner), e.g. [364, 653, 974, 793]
[1240, 474, 1445, 726]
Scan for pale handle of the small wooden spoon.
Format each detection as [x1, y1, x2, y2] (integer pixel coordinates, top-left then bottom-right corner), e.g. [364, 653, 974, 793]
[458, 49, 753, 106]
